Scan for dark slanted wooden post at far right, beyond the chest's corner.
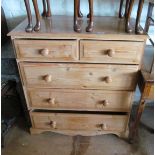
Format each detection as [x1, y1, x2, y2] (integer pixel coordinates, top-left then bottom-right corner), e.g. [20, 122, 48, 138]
[144, 3, 154, 33]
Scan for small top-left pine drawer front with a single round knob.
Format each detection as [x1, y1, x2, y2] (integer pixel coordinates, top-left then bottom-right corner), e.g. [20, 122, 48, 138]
[14, 40, 79, 61]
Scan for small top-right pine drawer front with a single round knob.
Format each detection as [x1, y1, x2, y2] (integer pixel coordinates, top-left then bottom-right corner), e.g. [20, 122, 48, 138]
[80, 40, 144, 64]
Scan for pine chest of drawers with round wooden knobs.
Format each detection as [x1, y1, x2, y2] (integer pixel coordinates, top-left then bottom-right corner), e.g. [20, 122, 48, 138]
[9, 16, 146, 136]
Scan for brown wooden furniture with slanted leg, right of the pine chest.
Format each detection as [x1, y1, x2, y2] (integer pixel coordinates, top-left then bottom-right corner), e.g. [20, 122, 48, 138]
[129, 1, 154, 143]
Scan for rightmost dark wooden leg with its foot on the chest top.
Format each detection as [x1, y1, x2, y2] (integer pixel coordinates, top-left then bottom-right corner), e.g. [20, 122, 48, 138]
[135, 0, 144, 34]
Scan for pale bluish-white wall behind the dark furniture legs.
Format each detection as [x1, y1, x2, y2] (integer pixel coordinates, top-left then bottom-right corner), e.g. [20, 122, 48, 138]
[1, 0, 147, 30]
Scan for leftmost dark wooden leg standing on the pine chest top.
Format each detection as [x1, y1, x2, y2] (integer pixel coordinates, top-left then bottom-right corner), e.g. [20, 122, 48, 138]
[24, 0, 33, 32]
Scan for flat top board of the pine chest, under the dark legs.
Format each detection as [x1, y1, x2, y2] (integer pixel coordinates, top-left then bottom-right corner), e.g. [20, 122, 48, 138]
[8, 16, 147, 41]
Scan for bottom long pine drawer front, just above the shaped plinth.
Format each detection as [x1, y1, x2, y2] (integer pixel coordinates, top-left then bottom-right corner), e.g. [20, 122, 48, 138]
[30, 112, 128, 132]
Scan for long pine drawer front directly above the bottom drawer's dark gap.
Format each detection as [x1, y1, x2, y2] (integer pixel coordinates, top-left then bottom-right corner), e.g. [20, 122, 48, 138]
[28, 89, 132, 112]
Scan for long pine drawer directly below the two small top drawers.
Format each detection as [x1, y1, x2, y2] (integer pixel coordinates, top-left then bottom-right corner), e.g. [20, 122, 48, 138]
[20, 63, 138, 90]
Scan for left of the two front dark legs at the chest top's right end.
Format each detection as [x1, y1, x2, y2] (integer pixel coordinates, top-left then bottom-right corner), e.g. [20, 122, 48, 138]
[125, 0, 135, 33]
